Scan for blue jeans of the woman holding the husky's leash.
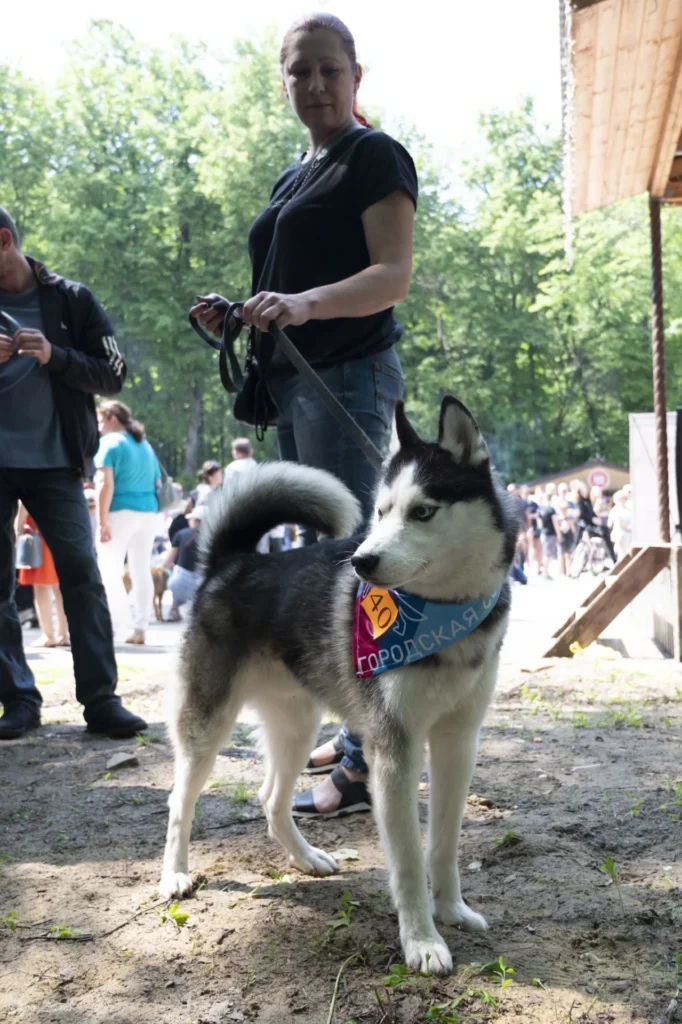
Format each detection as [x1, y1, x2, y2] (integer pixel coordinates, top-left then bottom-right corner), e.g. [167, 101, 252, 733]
[268, 348, 402, 772]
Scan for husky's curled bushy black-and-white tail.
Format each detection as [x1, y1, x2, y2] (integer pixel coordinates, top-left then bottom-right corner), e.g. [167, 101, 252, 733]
[200, 462, 360, 574]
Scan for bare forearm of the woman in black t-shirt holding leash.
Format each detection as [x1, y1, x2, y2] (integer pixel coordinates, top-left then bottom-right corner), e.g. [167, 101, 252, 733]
[303, 263, 412, 319]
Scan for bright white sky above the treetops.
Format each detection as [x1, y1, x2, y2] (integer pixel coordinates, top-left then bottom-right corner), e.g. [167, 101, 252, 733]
[5, 0, 560, 162]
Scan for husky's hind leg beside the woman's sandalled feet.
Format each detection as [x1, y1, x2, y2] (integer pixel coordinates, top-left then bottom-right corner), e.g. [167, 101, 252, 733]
[258, 693, 337, 876]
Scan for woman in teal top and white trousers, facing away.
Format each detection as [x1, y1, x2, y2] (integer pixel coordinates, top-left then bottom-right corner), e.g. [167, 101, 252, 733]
[95, 401, 161, 644]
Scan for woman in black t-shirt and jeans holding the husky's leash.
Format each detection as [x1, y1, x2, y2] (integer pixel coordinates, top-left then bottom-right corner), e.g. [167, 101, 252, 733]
[191, 13, 418, 817]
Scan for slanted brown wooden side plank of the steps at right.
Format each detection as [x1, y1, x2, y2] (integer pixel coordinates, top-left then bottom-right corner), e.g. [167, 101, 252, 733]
[544, 545, 671, 657]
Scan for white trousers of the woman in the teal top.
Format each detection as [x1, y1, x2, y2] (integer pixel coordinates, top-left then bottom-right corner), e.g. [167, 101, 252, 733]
[97, 509, 158, 634]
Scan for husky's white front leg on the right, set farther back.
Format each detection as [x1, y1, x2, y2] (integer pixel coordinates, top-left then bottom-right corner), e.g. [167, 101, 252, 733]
[428, 713, 487, 932]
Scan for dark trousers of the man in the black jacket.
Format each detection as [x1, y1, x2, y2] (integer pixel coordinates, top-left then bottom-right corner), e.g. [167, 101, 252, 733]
[0, 469, 117, 718]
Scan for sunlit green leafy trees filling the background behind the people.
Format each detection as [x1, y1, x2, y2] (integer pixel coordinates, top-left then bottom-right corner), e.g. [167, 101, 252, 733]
[0, 22, 682, 473]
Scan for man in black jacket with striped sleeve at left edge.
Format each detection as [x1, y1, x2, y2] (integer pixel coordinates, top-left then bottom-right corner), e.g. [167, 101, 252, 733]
[0, 207, 146, 739]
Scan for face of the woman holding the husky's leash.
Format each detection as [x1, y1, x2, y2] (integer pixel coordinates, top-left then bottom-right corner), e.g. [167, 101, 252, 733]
[282, 29, 363, 137]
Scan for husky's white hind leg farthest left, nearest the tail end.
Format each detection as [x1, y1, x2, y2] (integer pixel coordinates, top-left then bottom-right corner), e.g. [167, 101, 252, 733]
[159, 699, 240, 899]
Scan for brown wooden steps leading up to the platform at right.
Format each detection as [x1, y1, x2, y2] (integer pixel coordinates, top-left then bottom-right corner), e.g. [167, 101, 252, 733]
[544, 544, 671, 657]
